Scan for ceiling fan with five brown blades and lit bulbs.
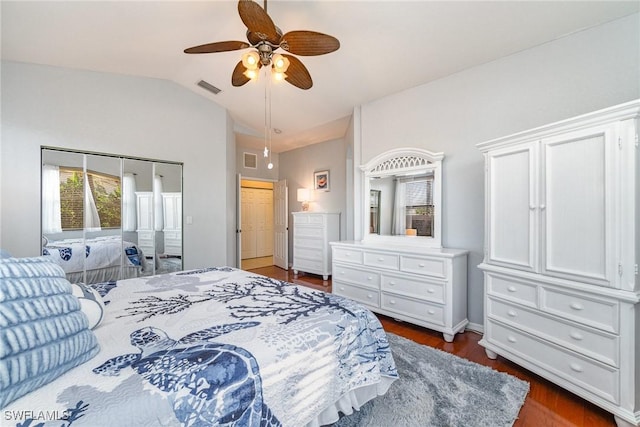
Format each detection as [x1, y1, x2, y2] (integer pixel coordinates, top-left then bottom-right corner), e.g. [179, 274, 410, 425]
[184, 0, 340, 89]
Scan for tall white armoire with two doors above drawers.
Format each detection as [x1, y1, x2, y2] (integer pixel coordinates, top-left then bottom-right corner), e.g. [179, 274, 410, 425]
[478, 101, 640, 426]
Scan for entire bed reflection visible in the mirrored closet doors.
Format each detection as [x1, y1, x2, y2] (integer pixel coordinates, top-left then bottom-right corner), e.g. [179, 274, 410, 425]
[42, 236, 148, 283]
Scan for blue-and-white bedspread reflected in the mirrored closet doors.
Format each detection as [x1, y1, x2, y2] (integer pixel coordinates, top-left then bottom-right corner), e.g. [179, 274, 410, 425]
[42, 236, 145, 273]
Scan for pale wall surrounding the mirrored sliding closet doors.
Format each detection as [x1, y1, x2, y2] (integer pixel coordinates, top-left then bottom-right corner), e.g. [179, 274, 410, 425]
[0, 62, 235, 268]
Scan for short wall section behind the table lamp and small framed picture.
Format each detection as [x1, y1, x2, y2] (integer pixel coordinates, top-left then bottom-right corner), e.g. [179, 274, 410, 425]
[279, 139, 347, 263]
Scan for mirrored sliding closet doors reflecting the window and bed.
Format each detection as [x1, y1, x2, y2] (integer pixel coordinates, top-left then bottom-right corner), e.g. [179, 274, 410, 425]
[41, 147, 182, 283]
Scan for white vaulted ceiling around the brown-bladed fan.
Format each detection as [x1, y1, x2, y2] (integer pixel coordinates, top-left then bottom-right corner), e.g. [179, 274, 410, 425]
[1, 0, 640, 152]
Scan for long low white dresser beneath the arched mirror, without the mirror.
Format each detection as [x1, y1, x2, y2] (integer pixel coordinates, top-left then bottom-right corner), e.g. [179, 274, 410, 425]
[331, 242, 468, 342]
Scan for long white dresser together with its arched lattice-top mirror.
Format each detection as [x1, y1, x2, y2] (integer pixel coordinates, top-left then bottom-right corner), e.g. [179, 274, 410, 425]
[331, 149, 468, 342]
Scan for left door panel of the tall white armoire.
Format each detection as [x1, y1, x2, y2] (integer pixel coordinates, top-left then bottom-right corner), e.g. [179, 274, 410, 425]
[487, 144, 536, 271]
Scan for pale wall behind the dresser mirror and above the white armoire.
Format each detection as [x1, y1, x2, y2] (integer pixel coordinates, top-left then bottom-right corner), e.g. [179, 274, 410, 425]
[355, 14, 640, 324]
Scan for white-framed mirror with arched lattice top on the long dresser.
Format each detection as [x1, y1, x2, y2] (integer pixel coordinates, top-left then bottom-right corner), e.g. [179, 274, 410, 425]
[361, 148, 444, 248]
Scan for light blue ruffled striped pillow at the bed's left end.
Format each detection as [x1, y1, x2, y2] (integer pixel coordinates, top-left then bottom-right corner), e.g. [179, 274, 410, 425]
[0, 257, 100, 408]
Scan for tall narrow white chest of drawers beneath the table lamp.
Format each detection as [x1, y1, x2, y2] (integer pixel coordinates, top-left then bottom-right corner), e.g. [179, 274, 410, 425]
[292, 212, 340, 280]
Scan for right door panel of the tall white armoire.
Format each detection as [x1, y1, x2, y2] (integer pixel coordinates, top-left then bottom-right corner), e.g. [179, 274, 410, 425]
[541, 126, 614, 285]
